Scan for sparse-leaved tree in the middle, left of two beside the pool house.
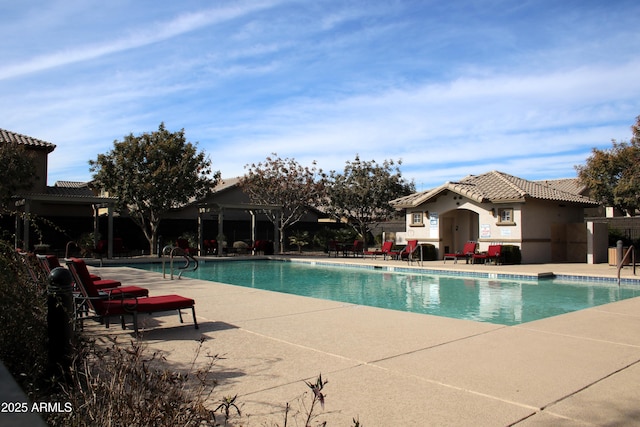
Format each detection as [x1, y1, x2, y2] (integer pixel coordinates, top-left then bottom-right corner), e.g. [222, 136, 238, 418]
[240, 153, 325, 250]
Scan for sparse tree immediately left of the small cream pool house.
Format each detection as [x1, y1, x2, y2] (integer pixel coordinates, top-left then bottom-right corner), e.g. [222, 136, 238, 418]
[328, 155, 415, 246]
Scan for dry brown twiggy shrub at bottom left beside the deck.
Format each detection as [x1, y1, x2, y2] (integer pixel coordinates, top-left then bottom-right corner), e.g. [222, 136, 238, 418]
[46, 338, 220, 427]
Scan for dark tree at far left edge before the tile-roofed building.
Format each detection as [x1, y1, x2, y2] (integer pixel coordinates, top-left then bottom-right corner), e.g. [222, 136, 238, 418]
[0, 141, 34, 213]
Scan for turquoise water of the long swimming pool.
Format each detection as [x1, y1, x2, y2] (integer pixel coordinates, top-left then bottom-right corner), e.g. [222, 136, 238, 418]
[131, 260, 640, 325]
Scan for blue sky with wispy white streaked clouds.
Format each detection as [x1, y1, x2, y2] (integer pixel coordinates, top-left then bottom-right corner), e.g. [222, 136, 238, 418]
[0, 0, 640, 189]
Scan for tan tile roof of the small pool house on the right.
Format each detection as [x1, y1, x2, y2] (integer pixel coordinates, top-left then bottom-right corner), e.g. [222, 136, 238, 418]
[391, 171, 598, 208]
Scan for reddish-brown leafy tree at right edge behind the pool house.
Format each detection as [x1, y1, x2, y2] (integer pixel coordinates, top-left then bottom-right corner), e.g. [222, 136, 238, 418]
[576, 116, 640, 215]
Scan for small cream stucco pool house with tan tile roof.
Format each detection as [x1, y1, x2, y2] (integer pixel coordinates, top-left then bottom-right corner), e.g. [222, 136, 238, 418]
[391, 171, 599, 263]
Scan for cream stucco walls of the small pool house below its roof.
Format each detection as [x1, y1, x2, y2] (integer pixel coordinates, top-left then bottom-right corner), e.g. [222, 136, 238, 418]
[401, 192, 586, 263]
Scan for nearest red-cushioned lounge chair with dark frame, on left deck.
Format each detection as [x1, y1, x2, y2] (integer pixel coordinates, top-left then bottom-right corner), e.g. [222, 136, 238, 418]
[67, 258, 198, 334]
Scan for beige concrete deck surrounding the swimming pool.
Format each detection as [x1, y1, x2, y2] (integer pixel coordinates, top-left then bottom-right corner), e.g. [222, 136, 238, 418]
[87, 256, 640, 427]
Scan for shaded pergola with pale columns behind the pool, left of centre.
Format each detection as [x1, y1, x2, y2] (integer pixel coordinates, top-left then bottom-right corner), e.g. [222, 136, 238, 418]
[198, 203, 282, 254]
